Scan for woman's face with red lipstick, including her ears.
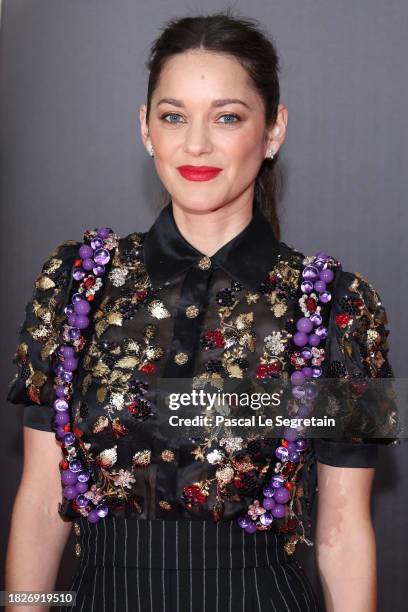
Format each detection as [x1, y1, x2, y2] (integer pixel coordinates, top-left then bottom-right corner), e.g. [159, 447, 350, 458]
[140, 51, 288, 212]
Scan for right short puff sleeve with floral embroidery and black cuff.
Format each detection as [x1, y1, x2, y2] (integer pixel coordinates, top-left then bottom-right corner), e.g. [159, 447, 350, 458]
[313, 267, 399, 467]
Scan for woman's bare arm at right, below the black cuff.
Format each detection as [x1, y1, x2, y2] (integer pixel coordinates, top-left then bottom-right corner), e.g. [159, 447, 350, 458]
[316, 462, 377, 612]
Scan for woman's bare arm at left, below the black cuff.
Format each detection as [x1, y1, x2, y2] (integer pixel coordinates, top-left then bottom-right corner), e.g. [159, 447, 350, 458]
[5, 427, 72, 612]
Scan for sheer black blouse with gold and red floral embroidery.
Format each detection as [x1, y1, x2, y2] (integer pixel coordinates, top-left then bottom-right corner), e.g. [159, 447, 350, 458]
[7, 201, 394, 550]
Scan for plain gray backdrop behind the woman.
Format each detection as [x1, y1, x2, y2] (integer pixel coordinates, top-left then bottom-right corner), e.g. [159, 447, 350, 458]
[0, 0, 408, 611]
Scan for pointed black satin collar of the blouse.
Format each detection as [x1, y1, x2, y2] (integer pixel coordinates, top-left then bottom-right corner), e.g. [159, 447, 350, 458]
[143, 200, 279, 291]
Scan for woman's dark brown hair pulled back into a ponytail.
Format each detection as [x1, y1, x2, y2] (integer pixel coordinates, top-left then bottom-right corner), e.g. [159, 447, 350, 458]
[146, 8, 281, 239]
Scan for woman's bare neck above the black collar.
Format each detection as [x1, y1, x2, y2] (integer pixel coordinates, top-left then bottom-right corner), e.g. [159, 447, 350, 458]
[172, 195, 253, 257]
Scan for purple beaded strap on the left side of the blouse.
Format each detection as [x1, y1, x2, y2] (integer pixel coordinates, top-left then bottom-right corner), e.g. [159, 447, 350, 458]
[53, 228, 118, 523]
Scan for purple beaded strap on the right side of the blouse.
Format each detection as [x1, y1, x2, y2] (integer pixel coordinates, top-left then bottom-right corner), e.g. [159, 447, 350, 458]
[237, 251, 338, 533]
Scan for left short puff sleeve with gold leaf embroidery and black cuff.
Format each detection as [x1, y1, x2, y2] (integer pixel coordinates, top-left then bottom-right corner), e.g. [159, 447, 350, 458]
[7, 240, 81, 432]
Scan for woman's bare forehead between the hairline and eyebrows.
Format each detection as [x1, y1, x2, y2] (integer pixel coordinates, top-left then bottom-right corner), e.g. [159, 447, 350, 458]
[154, 50, 256, 99]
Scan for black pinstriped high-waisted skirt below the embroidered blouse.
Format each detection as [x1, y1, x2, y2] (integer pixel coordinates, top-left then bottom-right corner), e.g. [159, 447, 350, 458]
[62, 517, 319, 612]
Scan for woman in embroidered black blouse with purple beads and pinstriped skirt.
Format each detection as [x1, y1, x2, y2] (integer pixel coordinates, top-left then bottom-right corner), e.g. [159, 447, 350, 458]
[3, 12, 398, 612]
